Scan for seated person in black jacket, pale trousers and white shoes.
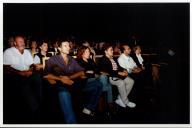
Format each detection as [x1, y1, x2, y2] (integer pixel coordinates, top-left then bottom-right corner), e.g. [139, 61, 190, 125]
[99, 45, 136, 108]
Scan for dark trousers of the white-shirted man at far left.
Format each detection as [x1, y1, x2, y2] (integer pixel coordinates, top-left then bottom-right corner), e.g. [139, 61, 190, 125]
[3, 73, 42, 123]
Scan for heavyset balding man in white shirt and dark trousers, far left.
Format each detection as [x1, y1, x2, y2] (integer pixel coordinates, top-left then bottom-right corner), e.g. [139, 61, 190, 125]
[3, 36, 42, 121]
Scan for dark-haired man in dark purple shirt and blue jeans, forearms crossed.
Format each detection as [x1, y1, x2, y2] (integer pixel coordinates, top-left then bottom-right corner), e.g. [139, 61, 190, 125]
[44, 40, 102, 123]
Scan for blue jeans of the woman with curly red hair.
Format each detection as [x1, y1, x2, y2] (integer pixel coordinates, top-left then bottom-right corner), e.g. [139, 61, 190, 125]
[88, 75, 113, 103]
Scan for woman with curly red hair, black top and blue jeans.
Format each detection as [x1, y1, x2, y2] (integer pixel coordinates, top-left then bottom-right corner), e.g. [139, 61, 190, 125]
[77, 46, 113, 110]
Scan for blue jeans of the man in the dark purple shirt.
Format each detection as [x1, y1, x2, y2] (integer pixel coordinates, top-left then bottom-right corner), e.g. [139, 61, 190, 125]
[56, 81, 102, 124]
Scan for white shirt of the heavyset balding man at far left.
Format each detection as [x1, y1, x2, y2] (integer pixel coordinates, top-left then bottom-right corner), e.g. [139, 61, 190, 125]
[3, 47, 33, 71]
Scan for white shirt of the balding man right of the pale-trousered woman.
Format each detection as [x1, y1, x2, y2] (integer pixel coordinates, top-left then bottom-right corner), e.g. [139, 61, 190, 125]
[118, 54, 137, 73]
